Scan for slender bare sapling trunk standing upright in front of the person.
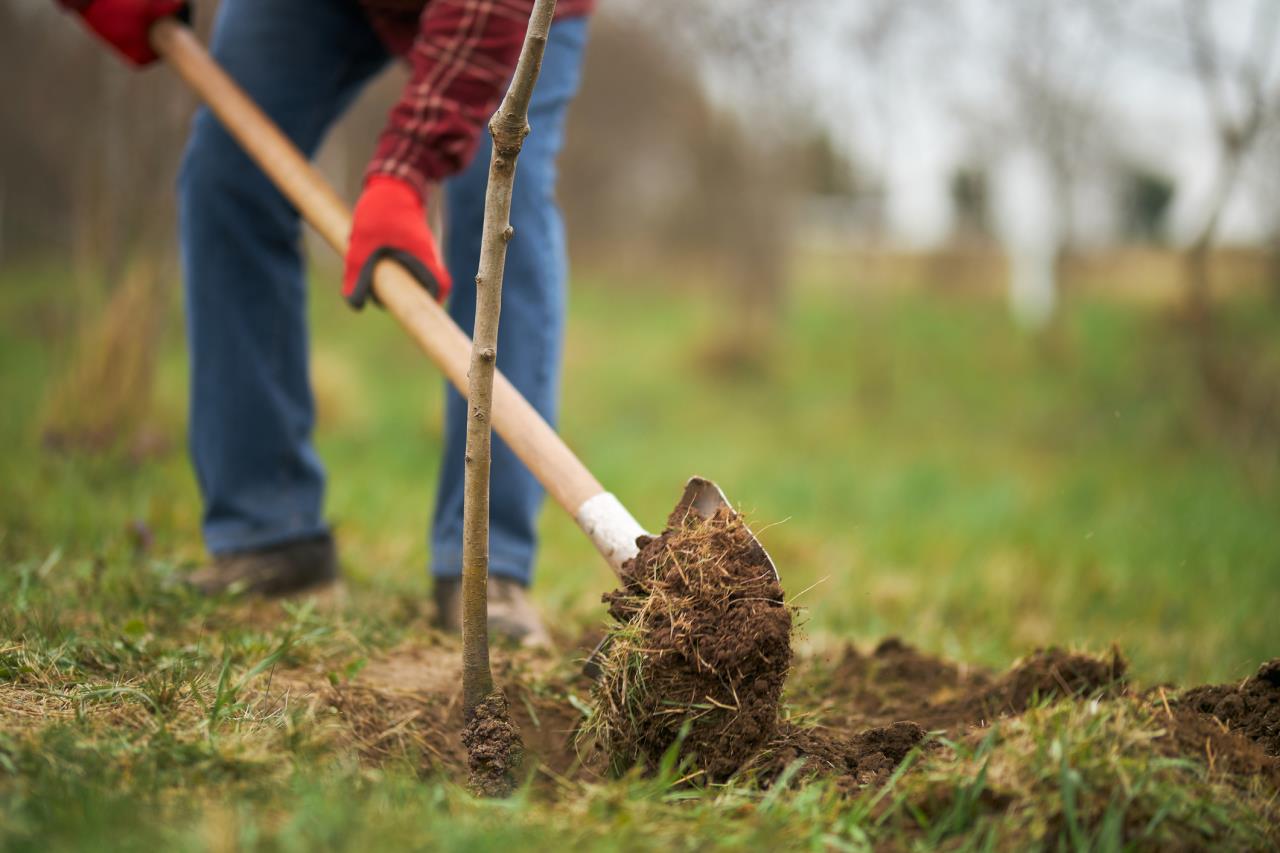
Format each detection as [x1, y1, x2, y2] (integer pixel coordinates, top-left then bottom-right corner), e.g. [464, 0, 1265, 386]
[462, 0, 556, 720]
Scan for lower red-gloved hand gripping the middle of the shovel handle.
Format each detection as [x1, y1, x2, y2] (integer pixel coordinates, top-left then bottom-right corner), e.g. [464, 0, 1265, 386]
[342, 174, 453, 309]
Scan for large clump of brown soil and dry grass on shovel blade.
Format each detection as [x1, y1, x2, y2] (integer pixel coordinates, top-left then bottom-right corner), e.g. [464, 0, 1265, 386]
[593, 507, 791, 781]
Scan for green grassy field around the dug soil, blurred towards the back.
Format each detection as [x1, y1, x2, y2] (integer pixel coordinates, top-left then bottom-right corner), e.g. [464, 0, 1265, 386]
[0, 261, 1280, 849]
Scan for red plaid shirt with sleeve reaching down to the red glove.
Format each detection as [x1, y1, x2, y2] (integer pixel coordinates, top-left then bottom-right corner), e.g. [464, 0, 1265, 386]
[361, 0, 594, 196]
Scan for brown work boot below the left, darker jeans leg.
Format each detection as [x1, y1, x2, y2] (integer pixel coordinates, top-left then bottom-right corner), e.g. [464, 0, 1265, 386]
[187, 533, 338, 598]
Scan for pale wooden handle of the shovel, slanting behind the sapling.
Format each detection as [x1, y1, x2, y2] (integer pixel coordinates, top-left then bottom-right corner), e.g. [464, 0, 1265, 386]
[151, 19, 604, 519]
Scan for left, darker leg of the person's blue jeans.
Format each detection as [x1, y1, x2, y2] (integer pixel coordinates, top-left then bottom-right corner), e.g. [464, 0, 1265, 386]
[179, 0, 388, 553]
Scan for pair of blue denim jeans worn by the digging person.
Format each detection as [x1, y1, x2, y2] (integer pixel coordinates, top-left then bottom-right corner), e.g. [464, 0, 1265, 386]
[179, 0, 586, 584]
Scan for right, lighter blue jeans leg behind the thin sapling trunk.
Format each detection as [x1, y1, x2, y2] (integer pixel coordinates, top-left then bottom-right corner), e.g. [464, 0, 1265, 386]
[431, 18, 586, 585]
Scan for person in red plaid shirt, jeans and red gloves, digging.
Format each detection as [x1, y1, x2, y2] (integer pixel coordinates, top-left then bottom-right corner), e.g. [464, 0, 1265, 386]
[59, 0, 591, 644]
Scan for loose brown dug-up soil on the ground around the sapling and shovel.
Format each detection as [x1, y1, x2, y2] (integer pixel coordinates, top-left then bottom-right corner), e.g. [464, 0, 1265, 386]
[257, 627, 1280, 790]
